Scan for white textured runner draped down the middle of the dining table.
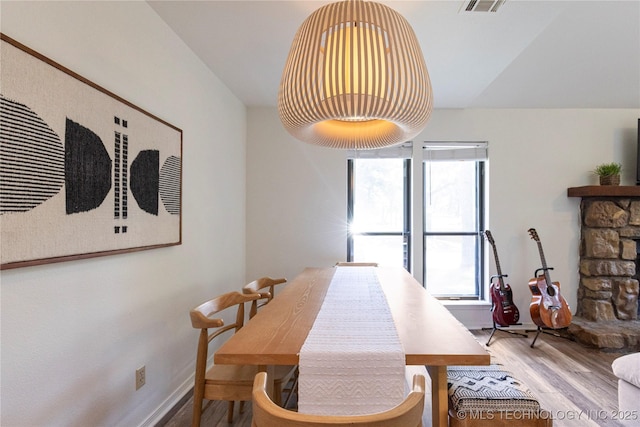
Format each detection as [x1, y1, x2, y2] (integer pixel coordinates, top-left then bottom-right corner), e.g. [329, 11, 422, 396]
[298, 267, 405, 415]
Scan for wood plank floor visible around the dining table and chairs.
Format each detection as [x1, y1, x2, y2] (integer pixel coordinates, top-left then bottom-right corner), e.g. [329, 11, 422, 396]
[158, 331, 622, 427]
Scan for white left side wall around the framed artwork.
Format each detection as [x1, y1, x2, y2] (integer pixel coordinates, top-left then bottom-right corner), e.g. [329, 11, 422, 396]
[0, 1, 246, 427]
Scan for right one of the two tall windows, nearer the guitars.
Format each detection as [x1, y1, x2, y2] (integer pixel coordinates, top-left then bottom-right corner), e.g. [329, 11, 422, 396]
[423, 143, 486, 299]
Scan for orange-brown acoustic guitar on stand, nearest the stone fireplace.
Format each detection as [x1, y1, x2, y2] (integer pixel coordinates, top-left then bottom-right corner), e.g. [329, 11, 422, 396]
[529, 228, 572, 329]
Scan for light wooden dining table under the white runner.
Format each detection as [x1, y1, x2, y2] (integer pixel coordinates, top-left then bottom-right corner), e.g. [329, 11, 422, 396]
[214, 267, 491, 427]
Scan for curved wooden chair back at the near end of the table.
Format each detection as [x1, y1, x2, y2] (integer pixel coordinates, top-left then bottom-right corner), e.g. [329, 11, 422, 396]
[251, 372, 425, 427]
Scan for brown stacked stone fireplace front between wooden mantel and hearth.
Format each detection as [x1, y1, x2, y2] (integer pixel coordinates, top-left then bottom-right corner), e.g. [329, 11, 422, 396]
[576, 197, 640, 321]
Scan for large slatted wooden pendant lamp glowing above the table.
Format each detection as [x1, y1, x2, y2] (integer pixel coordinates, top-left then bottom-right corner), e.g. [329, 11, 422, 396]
[278, 0, 433, 149]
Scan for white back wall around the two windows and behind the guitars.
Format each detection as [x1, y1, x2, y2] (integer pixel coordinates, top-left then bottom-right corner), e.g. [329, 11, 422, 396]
[247, 108, 640, 327]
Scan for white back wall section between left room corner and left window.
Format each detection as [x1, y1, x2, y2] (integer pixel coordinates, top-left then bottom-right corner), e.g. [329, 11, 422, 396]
[247, 107, 347, 279]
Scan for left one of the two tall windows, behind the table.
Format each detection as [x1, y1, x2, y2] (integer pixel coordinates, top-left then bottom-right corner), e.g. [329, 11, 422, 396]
[347, 147, 411, 269]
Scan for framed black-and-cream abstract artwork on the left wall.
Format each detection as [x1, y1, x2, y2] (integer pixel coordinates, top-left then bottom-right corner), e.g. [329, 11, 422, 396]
[0, 34, 182, 269]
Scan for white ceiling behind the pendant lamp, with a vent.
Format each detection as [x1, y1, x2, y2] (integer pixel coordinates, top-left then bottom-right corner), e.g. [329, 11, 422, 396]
[148, 0, 640, 108]
